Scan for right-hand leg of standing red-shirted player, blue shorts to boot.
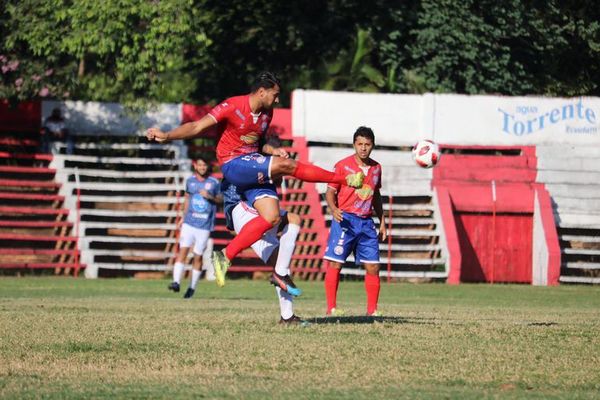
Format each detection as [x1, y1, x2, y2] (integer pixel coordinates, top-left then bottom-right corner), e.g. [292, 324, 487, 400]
[355, 218, 381, 316]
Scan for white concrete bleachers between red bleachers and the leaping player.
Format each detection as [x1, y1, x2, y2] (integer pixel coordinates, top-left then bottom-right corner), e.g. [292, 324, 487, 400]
[52, 135, 190, 278]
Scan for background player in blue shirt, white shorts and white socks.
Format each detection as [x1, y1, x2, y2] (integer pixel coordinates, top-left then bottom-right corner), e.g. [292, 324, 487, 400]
[169, 157, 221, 299]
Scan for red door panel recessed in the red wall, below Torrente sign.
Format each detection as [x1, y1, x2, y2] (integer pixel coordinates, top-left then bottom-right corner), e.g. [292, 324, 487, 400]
[455, 213, 533, 283]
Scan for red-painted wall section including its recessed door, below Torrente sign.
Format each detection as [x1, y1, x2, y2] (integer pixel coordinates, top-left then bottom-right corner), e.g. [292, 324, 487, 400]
[432, 147, 537, 283]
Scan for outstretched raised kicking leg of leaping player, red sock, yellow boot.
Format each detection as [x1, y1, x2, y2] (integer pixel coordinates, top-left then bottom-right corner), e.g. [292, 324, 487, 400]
[270, 157, 365, 187]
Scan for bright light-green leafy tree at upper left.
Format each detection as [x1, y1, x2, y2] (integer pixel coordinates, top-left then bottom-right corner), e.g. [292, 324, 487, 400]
[2, 0, 210, 102]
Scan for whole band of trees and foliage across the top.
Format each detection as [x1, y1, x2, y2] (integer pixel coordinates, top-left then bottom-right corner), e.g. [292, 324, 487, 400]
[0, 0, 600, 105]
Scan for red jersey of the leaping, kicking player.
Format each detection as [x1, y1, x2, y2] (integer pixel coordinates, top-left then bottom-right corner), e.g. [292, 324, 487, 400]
[209, 95, 273, 165]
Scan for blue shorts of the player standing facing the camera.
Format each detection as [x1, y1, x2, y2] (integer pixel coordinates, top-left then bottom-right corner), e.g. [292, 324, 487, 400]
[324, 212, 379, 264]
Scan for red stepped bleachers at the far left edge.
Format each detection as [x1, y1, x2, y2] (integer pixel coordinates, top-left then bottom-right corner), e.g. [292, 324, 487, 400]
[0, 129, 85, 276]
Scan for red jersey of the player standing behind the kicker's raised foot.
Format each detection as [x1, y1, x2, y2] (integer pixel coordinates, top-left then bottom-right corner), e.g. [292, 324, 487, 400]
[327, 154, 381, 217]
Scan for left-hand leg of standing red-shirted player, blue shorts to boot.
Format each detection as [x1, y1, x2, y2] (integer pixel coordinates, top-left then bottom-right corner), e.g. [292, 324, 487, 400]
[324, 213, 356, 316]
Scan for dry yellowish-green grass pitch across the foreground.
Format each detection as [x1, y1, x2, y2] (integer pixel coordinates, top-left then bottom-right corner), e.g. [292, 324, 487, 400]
[0, 278, 600, 400]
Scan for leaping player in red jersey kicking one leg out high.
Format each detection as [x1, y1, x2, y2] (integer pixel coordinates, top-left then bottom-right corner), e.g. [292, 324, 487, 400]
[146, 72, 364, 286]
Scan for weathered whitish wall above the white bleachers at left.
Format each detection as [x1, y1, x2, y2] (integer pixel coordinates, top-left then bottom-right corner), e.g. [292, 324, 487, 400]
[42, 101, 182, 135]
